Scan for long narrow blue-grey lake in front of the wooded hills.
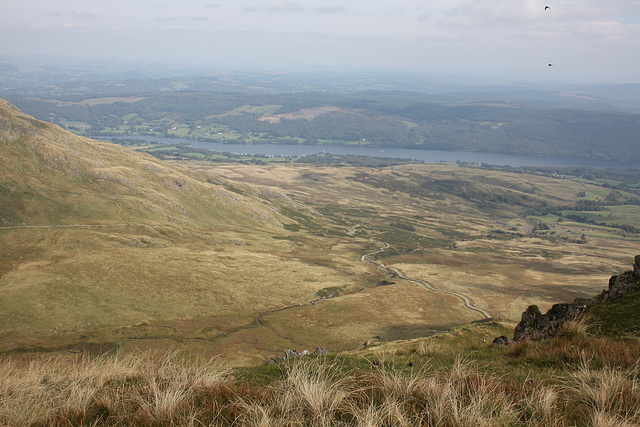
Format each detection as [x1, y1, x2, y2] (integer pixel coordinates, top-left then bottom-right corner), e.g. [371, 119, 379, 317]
[111, 135, 640, 169]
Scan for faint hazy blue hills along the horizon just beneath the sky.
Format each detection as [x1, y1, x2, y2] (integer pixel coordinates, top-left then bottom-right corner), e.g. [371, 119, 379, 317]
[0, 63, 640, 113]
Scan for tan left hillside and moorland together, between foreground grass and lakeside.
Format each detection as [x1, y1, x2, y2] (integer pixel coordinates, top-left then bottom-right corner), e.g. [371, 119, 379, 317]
[0, 98, 637, 363]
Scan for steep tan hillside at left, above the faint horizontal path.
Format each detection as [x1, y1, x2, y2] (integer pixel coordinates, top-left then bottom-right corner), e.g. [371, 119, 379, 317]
[0, 100, 289, 228]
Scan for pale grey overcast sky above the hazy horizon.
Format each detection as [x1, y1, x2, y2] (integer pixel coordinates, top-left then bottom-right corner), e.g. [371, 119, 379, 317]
[0, 0, 640, 83]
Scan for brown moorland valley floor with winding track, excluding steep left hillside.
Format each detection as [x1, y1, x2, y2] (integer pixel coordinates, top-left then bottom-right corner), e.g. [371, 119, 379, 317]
[0, 159, 640, 365]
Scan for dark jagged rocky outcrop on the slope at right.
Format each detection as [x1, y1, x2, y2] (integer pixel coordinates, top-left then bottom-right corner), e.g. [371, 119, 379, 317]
[510, 255, 640, 344]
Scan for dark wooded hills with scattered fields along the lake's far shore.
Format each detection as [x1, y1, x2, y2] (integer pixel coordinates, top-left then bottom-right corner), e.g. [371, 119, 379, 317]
[6, 90, 640, 161]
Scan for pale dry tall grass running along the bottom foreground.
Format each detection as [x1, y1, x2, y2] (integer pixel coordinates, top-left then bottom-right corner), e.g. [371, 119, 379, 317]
[0, 353, 640, 427]
